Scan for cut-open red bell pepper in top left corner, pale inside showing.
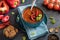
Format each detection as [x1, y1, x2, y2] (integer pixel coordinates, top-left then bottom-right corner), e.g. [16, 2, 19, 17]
[0, 1, 9, 15]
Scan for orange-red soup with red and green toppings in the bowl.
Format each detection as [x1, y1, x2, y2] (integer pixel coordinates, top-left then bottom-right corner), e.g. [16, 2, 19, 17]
[22, 7, 43, 23]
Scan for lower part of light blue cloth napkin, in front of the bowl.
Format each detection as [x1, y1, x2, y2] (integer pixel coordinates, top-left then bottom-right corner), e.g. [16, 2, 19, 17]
[24, 21, 48, 40]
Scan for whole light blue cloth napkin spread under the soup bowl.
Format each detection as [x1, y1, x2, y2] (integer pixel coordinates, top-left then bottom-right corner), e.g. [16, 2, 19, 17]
[18, 4, 48, 40]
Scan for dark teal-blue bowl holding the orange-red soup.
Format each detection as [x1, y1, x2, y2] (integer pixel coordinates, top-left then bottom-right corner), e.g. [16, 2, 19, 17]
[21, 6, 44, 27]
